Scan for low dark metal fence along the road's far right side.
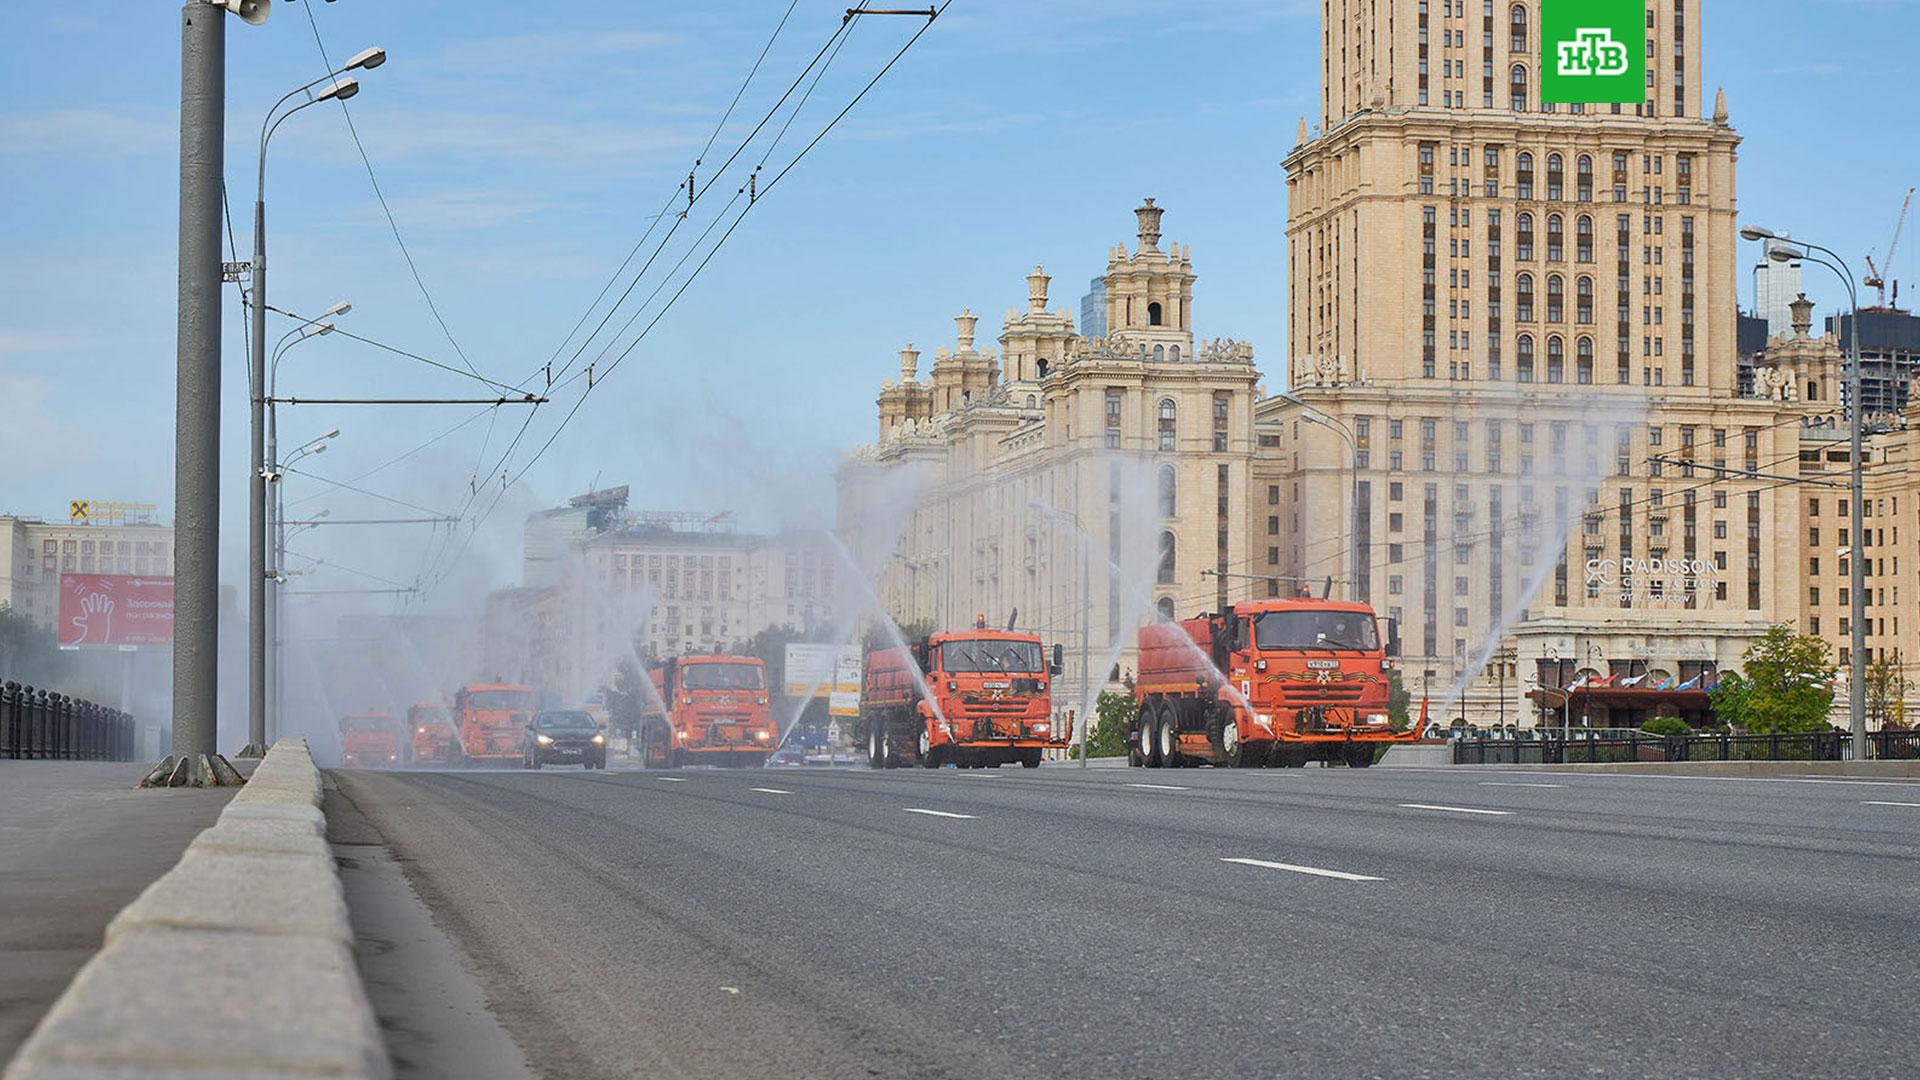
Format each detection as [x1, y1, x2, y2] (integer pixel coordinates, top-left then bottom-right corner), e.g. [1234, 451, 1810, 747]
[1453, 730, 1920, 765]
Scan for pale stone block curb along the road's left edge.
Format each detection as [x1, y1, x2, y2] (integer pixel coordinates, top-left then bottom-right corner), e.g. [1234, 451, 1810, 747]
[4, 740, 392, 1080]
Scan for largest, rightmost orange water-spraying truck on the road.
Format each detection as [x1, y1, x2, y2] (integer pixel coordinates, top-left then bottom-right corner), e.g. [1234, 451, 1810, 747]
[1129, 598, 1419, 769]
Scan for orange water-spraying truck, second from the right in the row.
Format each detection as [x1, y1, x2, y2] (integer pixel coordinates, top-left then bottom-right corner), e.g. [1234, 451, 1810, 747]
[854, 628, 1071, 769]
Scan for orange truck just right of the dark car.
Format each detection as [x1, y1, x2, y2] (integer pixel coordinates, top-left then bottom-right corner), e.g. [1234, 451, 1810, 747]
[639, 653, 776, 769]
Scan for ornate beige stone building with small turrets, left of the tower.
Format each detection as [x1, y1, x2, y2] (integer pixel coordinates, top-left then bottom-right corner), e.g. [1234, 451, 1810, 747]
[839, 200, 1260, 707]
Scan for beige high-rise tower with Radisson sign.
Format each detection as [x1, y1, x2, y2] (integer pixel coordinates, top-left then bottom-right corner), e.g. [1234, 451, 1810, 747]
[1254, 0, 1807, 723]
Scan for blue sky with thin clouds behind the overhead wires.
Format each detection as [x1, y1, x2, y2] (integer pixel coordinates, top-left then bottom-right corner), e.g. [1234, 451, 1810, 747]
[0, 0, 1920, 599]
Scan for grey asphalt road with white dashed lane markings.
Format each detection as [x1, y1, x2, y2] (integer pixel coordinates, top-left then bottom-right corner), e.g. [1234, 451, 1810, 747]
[336, 767, 1920, 1078]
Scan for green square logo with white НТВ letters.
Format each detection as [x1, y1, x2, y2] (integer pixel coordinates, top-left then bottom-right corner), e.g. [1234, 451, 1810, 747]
[1540, 0, 1647, 104]
